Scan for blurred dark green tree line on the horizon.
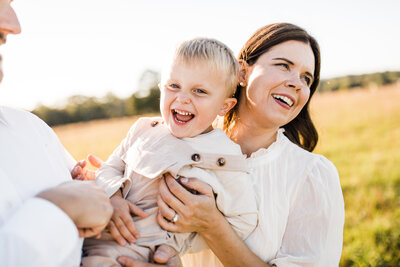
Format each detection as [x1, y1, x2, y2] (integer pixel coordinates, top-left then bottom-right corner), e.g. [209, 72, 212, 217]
[32, 70, 400, 126]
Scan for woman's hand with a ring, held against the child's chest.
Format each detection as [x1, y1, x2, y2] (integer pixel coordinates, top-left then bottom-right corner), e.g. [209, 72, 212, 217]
[157, 174, 221, 234]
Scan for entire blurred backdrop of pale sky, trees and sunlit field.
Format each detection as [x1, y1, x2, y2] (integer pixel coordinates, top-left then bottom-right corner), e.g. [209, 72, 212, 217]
[0, 0, 400, 266]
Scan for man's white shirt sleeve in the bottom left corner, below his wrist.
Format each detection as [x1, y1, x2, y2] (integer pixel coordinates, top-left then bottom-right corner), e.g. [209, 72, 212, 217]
[0, 198, 79, 267]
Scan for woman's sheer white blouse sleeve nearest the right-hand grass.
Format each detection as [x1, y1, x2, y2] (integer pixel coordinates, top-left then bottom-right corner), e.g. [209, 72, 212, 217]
[269, 156, 344, 266]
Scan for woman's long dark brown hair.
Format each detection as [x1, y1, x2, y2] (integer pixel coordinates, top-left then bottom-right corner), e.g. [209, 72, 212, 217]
[224, 23, 321, 151]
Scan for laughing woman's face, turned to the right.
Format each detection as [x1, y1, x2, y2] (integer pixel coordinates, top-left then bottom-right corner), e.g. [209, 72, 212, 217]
[239, 41, 315, 129]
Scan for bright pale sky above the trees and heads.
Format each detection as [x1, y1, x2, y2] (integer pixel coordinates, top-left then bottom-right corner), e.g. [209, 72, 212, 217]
[0, 0, 400, 109]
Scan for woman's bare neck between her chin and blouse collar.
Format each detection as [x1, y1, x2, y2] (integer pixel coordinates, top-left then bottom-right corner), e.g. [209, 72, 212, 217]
[228, 120, 278, 157]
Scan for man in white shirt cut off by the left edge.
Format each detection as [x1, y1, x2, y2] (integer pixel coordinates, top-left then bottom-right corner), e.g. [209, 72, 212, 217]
[0, 0, 112, 267]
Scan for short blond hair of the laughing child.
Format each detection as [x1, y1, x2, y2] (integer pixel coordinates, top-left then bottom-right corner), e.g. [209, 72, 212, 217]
[162, 38, 239, 96]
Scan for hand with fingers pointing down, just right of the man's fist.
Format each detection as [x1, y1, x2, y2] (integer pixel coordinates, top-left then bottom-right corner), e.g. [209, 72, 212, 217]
[107, 190, 148, 246]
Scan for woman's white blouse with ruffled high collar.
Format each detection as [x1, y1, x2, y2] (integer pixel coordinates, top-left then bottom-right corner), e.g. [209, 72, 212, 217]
[183, 129, 344, 267]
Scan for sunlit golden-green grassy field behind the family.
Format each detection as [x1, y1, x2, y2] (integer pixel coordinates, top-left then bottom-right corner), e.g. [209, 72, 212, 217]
[55, 84, 400, 266]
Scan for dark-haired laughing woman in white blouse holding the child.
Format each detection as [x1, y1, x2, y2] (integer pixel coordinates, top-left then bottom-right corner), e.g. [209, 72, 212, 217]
[158, 23, 344, 267]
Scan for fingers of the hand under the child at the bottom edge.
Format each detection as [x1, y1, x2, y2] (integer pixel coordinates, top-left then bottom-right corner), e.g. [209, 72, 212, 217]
[113, 245, 182, 267]
